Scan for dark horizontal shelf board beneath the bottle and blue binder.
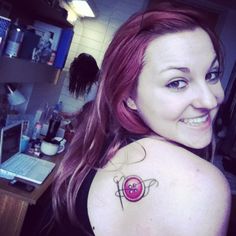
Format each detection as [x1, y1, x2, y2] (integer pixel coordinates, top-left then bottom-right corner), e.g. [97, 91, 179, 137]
[0, 56, 59, 83]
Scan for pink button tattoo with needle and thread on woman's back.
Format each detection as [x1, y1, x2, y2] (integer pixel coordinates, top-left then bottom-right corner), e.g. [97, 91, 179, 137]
[113, 175, 158, 210]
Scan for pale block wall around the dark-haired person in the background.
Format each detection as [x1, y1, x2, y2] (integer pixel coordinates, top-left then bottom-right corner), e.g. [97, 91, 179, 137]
[59, 0, 148, 112]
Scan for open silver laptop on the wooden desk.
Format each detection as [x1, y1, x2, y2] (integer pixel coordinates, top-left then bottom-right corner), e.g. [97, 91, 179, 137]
[0, 122, 55, 184]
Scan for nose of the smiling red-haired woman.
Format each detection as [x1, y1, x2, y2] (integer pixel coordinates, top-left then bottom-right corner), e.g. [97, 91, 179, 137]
[192, 84, 218, 110]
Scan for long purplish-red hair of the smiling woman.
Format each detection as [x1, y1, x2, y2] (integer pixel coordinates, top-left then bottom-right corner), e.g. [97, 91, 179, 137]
[53, 2, 223, 232]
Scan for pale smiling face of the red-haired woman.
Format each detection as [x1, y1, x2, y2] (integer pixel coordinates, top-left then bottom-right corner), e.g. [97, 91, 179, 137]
[133, 28, 224, 148]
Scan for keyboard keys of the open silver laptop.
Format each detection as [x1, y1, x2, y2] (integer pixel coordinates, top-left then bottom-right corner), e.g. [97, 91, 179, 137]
[5, 154, 38, 175]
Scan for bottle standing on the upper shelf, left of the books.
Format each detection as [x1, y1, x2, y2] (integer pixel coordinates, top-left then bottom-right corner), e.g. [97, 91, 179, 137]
[4, 20, 24, 57]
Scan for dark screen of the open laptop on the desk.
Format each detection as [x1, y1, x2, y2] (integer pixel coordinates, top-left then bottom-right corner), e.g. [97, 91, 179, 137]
[1, 123, 22, 163]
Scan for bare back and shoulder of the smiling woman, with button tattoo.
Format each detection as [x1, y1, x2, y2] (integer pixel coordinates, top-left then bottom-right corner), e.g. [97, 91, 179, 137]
[88, 138, 230, 236]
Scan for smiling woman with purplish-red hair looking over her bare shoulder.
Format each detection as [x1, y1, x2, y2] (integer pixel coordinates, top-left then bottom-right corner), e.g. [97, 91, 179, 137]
[53, 3, 230, 236]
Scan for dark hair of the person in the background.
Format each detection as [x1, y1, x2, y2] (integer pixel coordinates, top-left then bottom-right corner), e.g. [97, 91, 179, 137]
[69, 53, 99, 98]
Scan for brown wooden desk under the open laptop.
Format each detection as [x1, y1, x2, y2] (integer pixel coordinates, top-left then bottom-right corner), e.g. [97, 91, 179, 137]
[0, 153, 64, 236]
